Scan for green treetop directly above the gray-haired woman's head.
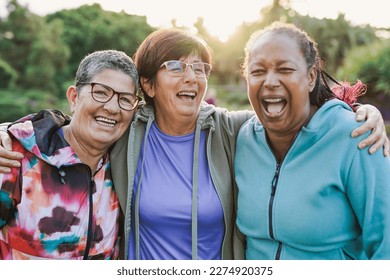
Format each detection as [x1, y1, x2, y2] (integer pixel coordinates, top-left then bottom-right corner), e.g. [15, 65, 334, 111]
[46, 4, 154, 78]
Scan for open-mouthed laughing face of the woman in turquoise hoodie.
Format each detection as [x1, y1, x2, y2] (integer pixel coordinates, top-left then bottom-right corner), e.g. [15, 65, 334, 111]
[247, 32, 316, 135]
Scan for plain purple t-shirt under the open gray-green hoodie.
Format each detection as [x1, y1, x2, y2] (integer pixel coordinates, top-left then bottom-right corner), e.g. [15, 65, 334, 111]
[129, 123, 224, 260]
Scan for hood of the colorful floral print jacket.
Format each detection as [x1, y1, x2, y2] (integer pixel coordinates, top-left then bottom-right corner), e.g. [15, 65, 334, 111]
[8, 110, 81, 167]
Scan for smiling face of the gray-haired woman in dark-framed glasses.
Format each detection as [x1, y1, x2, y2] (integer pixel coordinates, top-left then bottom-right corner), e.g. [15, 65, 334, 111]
[68, 70, 135, 147]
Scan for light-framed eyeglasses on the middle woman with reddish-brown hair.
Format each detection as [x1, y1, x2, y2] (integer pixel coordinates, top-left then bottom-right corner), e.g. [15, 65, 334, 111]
[160, 60, 211, 78]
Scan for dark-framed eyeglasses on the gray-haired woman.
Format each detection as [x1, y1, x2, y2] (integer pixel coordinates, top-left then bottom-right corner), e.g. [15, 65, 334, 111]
[76, 83, 141, 111]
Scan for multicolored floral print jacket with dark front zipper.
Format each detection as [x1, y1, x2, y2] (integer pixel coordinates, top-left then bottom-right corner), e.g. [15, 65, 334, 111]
[0, 110, 120, 260]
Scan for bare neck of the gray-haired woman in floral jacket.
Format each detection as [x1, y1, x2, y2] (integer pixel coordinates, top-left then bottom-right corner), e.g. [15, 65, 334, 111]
[63, 125, 108, 173]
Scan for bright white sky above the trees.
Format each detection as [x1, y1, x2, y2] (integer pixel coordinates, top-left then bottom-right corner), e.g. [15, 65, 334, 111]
[0, 0, 390, 40]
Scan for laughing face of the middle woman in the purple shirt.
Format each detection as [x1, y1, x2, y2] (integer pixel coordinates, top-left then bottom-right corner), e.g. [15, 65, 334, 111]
[148, 55, 207, 128]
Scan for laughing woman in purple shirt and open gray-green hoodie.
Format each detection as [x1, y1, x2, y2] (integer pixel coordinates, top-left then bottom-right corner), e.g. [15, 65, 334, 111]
[0, 29, 384, 259]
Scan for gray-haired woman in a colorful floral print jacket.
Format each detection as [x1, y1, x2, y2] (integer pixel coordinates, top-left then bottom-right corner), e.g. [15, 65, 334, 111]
[0, 51, 139, 259]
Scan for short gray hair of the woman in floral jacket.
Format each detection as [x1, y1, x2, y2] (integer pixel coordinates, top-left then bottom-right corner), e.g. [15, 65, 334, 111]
[75, 50, 138, 93]
